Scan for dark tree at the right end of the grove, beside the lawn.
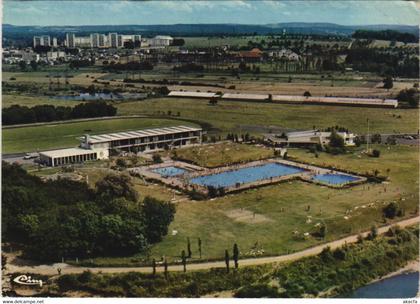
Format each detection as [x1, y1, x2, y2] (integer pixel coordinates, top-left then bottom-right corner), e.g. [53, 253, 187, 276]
[142, 196, 176, 244]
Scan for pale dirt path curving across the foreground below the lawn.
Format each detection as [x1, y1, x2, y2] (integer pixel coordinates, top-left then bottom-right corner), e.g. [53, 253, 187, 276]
[6, 216, 420, 275]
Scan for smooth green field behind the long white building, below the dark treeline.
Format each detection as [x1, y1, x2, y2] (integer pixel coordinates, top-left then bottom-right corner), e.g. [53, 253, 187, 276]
[2, 118, 199, 153]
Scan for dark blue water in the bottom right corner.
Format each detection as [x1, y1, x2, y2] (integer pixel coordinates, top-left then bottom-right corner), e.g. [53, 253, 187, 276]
[350, 272, 419, 299]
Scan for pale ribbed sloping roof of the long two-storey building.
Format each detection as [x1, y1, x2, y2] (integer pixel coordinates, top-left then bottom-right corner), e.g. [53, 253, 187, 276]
[88, 126, 201, 144]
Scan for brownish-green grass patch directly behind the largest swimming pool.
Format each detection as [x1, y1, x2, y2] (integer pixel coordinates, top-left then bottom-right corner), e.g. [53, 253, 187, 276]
[171, 143, 274, 167]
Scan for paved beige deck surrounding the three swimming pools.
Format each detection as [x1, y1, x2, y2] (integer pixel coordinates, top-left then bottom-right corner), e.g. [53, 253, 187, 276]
[129, 158, 367, 193]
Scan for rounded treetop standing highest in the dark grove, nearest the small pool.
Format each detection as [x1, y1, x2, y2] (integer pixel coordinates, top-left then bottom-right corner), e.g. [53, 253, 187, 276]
[96, 174, 139, 202]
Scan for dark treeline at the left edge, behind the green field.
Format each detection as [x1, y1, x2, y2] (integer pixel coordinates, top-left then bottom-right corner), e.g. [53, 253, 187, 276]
[2, 101, 117, 125]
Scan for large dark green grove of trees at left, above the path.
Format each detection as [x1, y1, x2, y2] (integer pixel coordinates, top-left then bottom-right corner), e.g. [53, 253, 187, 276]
[2, 162, 175, 262]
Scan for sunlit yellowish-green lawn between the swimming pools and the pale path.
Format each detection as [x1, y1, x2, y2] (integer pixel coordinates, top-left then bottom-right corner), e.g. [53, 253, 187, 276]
[82, 145, 419, 265]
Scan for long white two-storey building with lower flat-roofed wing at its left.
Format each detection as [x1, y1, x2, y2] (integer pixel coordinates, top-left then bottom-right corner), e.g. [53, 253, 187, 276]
[39, 126, 202, 167]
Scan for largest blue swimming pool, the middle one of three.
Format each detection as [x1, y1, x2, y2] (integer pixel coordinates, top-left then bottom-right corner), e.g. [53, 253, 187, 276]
[190, 163, 305, 188]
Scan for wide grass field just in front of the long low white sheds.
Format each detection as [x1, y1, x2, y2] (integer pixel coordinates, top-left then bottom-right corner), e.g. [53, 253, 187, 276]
[118, 98, 419, 134]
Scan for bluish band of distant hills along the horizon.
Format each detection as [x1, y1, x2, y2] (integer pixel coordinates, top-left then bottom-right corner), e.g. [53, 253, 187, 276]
[3, 22, 419, 39]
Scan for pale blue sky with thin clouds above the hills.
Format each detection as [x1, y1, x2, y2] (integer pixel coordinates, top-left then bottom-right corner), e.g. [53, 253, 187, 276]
[2, 0, 420, 26]
